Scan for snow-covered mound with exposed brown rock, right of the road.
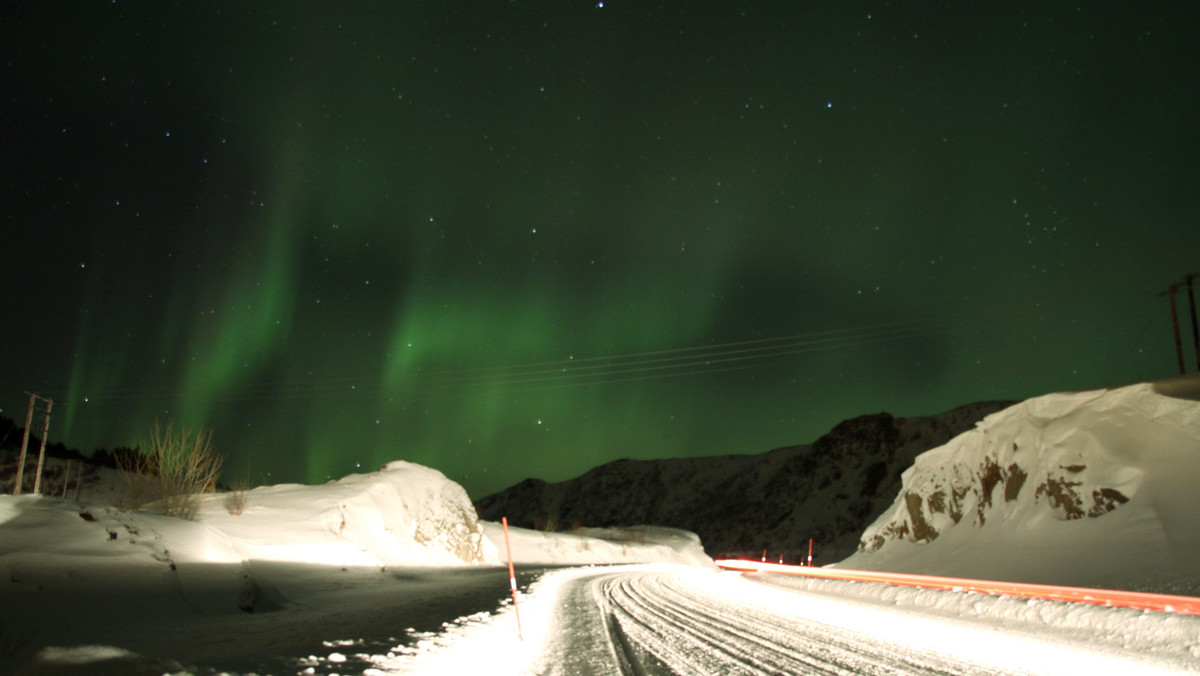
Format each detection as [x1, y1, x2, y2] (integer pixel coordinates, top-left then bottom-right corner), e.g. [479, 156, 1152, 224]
[842, 375, 1200, 594]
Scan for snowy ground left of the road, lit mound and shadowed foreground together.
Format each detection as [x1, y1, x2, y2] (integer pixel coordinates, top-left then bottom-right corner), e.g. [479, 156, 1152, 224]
[0, 461, 712, 674]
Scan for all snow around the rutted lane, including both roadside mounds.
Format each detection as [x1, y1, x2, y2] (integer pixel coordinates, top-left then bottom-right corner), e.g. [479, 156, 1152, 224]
[0, 377, 1200, 676]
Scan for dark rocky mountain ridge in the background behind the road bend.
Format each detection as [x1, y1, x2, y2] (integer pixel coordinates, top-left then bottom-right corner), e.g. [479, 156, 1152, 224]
[475, 402, 1010, 563]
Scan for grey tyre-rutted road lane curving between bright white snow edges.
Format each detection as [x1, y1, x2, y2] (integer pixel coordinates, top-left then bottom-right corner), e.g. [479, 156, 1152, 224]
[538, 572, 1012, 675]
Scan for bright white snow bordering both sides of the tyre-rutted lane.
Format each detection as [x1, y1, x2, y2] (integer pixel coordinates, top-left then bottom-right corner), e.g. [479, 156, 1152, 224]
[295, 564, 1200, 676]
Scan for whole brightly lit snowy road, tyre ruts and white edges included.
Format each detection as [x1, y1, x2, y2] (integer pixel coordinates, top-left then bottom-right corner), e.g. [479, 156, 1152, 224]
[403, 566, 1200, 676]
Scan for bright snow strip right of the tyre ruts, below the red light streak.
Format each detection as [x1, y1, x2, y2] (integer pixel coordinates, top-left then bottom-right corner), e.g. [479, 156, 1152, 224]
[728, 574, 1200, 675]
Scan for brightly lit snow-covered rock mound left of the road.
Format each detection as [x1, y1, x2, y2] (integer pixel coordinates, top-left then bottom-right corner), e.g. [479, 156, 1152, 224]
[0, 462, 499, 629]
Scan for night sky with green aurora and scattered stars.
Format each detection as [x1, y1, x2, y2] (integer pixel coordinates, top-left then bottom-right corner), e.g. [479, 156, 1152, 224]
[0, 0, 1200, 498]
